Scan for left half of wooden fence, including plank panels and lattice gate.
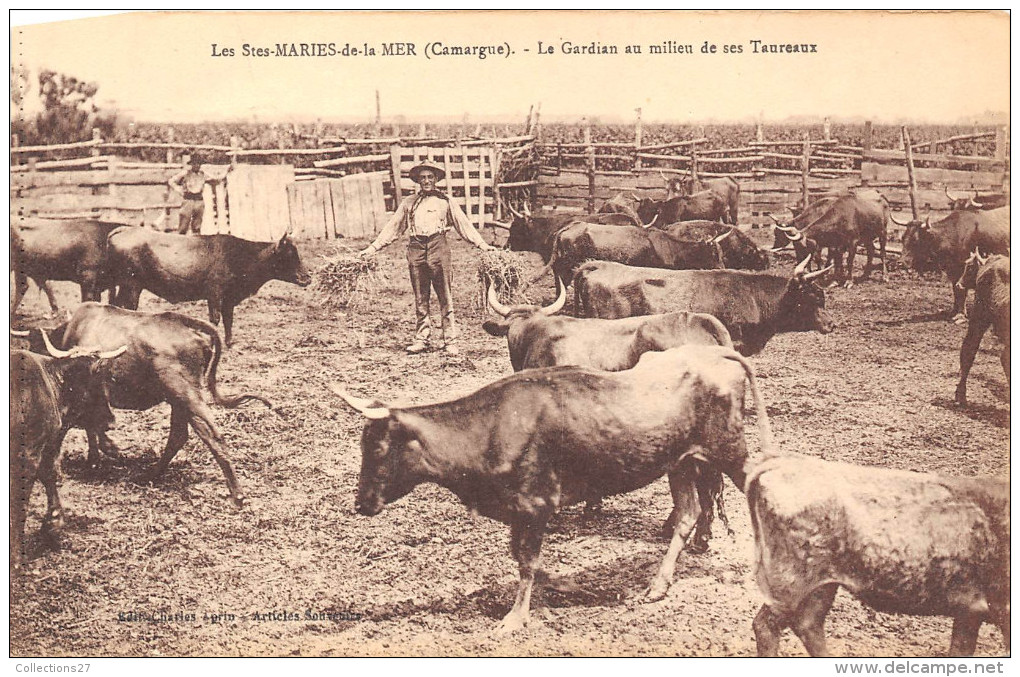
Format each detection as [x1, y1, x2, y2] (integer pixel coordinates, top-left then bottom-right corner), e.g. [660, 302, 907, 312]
[10, 130, 534, 241]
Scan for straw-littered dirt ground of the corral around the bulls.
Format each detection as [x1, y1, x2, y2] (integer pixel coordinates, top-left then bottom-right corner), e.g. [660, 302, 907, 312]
[10, 232, 1010, 657]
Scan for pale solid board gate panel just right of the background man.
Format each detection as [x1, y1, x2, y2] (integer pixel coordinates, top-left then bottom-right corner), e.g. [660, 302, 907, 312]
[226, 164, 294, 242]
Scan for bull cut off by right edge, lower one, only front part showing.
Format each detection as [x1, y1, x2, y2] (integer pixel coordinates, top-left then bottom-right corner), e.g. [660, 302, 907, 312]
[956, 251, 1010, 407]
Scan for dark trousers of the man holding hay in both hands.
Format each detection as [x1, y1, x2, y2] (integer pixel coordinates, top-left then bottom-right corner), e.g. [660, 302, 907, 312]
[407, 232, 459, 344]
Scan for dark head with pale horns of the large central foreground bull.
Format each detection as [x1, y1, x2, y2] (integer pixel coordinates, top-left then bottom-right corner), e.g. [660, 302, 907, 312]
[329, 384, 423, 517]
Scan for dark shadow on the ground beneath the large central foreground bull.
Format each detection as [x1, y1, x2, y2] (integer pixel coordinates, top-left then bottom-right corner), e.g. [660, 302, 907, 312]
[354, 543, 725, 629]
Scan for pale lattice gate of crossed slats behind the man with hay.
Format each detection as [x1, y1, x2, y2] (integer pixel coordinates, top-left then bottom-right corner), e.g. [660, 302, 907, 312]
[390, 144, 500, 227]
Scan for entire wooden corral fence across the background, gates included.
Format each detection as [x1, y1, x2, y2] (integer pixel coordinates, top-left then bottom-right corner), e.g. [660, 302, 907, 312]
[11, 117, 1009, 247]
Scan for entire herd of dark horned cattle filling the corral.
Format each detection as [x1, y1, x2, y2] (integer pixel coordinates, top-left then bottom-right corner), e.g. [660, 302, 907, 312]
[10, 173, 1010, 656]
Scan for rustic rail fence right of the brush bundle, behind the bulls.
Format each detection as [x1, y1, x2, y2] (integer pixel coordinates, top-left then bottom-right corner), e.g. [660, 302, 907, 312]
[538, 118, 1009, 225]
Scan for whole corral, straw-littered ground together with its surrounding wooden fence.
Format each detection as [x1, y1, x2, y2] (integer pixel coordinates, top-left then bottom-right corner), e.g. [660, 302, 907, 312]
[10, 118, 1010, 656]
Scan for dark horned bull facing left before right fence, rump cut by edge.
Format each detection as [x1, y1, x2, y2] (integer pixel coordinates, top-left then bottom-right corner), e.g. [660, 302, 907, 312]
[893, 207, 1010, 323]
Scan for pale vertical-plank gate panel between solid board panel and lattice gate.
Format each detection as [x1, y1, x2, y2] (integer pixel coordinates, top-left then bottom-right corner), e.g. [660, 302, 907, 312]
[287, 172, 387, 240]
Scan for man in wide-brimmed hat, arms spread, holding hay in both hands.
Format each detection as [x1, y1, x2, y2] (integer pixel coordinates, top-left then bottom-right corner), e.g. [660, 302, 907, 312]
[360, 161, 495, 355]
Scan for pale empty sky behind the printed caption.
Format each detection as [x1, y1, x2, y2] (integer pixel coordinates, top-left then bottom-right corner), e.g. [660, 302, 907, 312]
[11, 11, 1010, 122]
